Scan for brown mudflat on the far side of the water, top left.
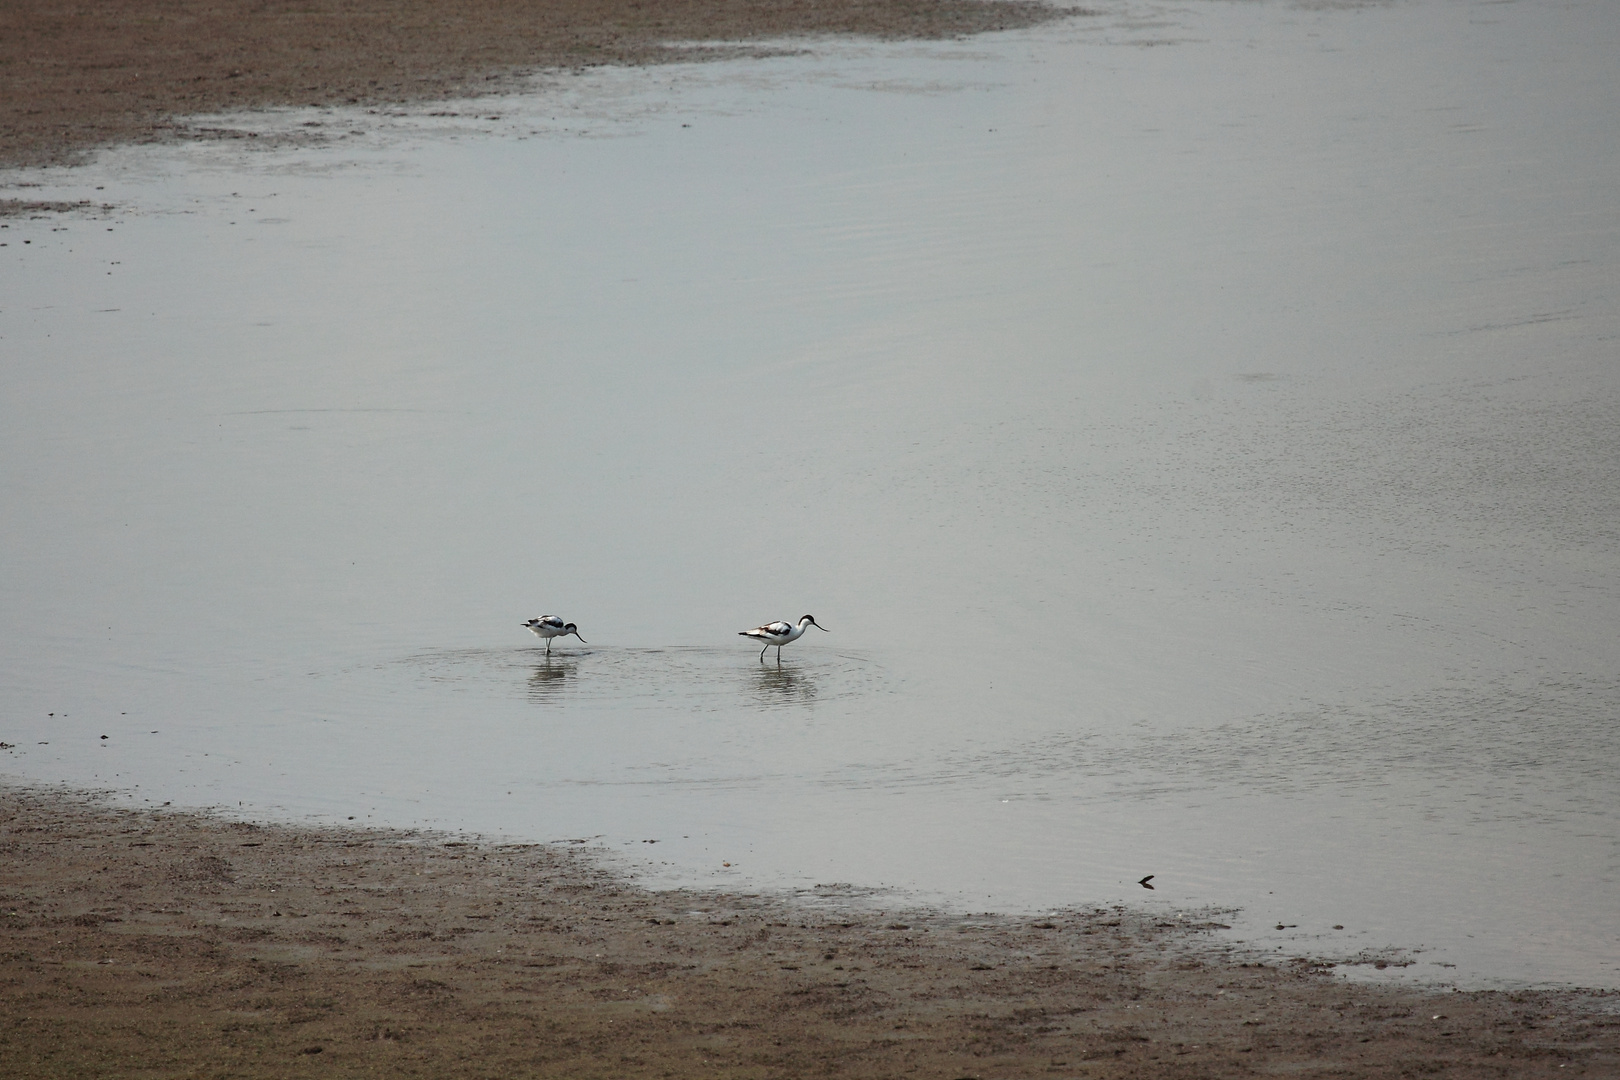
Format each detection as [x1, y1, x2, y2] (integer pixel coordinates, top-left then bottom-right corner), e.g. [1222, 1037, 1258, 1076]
[0, 0, 1059, 170]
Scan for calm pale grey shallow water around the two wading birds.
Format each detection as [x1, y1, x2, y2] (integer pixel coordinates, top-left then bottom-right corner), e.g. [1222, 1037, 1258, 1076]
[0, 0, 1620, 986]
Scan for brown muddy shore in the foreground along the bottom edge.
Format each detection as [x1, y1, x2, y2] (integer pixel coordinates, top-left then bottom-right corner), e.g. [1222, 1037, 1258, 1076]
[0, 789, 1620, 1077]
